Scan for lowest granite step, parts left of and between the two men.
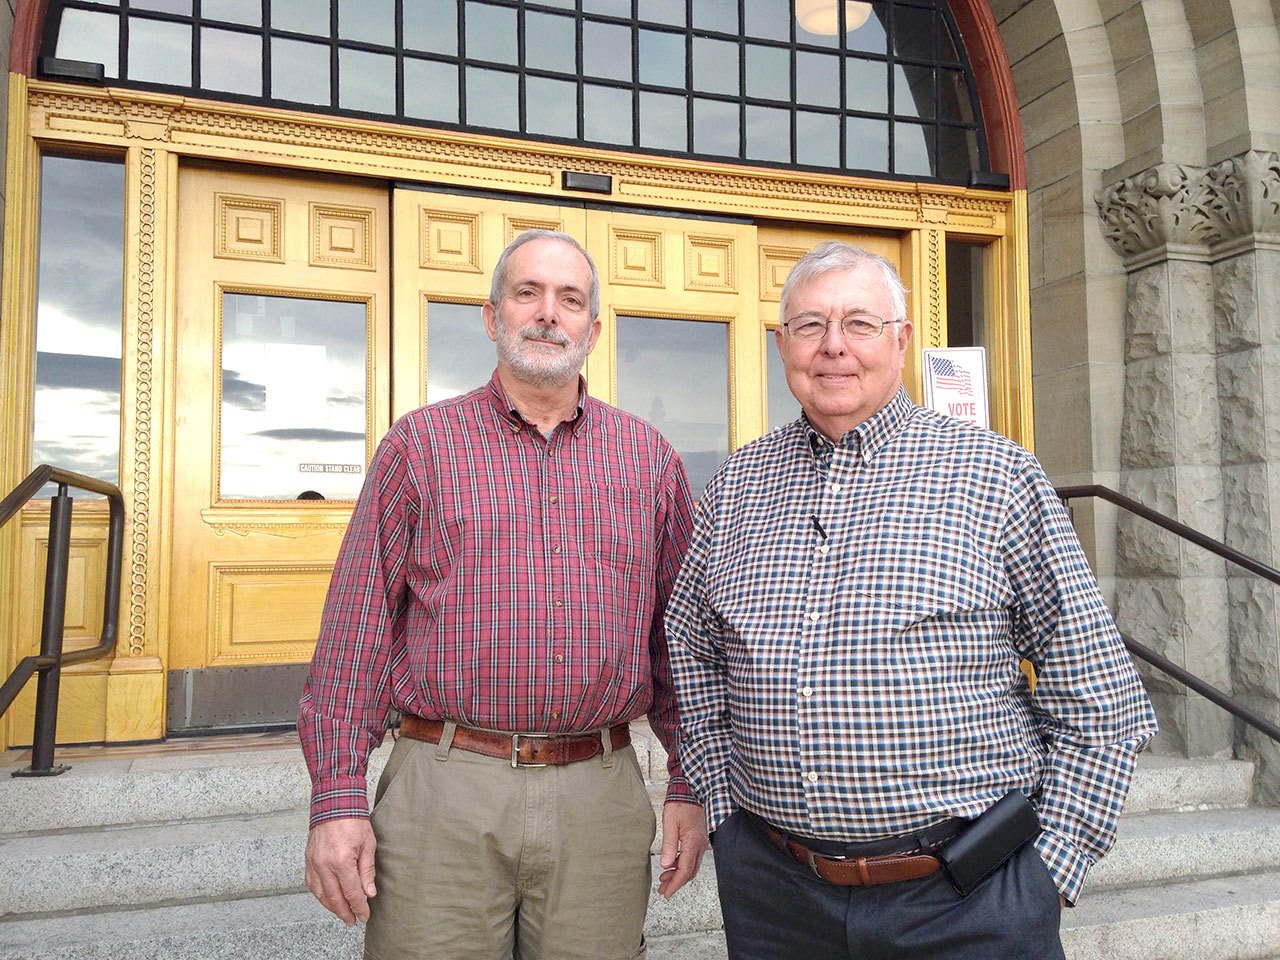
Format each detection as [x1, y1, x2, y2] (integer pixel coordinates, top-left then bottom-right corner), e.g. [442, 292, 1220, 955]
[0, 856, 721, 960]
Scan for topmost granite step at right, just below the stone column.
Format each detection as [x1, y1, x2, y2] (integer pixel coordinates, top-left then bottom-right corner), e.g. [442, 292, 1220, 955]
[1124, 754, 1253, 815]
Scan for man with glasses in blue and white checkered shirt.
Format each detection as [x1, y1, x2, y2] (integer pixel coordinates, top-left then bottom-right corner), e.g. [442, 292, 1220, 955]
[667, 243, 1156, 960]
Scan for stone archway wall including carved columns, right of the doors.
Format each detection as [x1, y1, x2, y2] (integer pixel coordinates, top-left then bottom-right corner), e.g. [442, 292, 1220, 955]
[991, 0, 1280, 796]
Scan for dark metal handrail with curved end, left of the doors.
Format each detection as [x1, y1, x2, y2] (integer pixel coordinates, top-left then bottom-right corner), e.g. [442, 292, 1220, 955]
[0, 463, 124, 777]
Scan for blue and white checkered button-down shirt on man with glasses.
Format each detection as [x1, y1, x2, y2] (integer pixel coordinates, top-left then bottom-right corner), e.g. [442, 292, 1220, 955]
[667, 389, 1156, 902]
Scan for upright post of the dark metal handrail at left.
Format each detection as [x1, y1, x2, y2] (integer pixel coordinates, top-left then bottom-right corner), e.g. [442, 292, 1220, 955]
[13, 483, 72, 777]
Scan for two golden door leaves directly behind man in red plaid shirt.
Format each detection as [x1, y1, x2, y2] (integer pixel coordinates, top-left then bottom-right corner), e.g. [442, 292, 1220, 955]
[394, 189, 763, 489]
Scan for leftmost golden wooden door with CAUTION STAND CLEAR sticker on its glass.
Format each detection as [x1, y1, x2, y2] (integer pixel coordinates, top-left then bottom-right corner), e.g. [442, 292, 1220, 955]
[166, 166, 390, 691]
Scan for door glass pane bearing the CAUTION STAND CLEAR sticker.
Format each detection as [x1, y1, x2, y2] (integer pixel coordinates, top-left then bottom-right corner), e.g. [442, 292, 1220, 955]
[220, 293, 369, 500]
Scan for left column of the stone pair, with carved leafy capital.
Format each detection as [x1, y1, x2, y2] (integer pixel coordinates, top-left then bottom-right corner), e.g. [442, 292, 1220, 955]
[1098, 164, 1234, 756]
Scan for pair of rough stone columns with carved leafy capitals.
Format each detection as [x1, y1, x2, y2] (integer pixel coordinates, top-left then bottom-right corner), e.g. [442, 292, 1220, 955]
[1097, 151, 1280, 801]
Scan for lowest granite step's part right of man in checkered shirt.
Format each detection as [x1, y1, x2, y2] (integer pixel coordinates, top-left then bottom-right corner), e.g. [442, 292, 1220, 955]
[1062, 870, 1280, 960]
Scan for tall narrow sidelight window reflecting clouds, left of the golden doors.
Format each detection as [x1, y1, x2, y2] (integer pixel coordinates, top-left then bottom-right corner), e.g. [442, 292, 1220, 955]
[31, 156, 124, 494]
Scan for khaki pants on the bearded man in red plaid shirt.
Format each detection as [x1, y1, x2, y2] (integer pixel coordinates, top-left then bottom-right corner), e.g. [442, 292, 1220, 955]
[365, 735, 655, 960]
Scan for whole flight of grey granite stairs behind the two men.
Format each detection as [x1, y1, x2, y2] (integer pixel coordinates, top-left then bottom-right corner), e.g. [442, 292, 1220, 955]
[0, 724, 1280, 960]
